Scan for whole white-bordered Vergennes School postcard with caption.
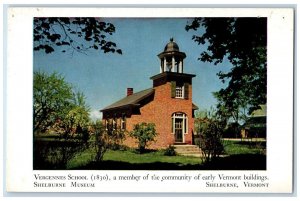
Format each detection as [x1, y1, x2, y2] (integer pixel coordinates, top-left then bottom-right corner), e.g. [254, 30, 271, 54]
[5, 7, 295, 194]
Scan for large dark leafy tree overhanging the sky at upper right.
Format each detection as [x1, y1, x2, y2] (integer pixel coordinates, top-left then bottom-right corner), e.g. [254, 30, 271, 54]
[186, 18, 267, 119]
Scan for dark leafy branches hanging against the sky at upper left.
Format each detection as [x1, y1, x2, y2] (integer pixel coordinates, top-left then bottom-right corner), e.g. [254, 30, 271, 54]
[33, 17, 122, 54]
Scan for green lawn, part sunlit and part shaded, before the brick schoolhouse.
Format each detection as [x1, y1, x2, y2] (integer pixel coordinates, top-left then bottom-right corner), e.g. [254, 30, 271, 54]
[35, 138, 266, 170]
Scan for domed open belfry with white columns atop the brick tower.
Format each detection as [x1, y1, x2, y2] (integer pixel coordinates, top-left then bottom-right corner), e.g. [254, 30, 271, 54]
[158, 38, 186, 73]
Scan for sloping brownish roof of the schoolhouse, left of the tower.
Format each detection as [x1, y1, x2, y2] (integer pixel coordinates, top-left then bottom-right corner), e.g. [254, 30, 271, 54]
[100, 88, 154, 112]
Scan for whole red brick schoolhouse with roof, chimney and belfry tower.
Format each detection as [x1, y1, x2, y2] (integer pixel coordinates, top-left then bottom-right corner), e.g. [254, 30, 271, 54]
[101, 38, 198, 149]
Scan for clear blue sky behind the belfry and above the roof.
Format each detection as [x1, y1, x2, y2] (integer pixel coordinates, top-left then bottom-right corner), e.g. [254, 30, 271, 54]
[33, 18, 231, 120]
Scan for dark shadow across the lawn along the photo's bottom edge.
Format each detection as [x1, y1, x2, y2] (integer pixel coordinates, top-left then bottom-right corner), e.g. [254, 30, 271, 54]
[69, 154, 266, 170]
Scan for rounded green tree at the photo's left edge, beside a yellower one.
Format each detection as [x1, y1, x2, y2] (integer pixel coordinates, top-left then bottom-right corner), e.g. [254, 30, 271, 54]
[33, 72, 73, 133]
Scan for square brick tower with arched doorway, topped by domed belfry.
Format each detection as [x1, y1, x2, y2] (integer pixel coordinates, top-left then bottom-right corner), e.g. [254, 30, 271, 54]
[150, 38, 197, 144]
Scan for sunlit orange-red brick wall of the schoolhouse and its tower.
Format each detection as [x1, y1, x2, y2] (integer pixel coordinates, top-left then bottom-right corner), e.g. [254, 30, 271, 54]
[124, 82, 194, 149]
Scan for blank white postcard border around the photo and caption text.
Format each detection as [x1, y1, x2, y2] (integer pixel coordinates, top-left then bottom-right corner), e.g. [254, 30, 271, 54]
[5, 7, 294, 193]
